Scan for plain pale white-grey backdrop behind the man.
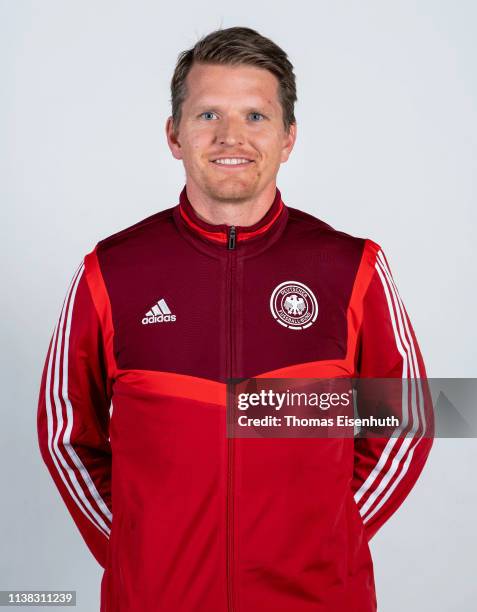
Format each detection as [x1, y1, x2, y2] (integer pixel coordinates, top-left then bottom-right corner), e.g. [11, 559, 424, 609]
[0, 0, 477, 612]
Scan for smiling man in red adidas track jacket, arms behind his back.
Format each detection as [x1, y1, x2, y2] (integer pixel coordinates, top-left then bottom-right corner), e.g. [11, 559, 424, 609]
[38, 27, 432, 612]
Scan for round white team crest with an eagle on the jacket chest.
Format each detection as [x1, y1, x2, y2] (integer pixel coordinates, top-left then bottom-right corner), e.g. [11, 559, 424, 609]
[270, 281, 318, 329]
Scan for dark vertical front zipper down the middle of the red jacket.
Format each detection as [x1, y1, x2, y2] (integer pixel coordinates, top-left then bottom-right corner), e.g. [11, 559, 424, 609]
[226, 225, 237, 612]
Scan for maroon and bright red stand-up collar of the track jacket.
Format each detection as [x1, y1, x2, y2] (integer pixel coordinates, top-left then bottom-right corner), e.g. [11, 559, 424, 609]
[174, 186, 288, 250]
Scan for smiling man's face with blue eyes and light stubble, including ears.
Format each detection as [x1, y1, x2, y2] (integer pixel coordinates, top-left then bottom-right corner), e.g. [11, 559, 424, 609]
[166, 64, 296, 202]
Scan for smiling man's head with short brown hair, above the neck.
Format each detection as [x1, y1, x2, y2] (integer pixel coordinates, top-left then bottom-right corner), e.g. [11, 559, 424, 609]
[166, 27, 296, 202]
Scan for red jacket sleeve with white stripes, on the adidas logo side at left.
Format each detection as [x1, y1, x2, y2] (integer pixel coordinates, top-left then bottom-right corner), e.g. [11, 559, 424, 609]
[37, 261, 112, 567]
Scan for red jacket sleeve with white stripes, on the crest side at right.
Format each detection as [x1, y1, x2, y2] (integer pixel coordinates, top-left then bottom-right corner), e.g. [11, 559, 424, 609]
[352, 240, 434, 541]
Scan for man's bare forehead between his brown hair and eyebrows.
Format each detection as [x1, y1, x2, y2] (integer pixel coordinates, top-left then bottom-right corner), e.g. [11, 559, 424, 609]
[185, 63, 280, 106]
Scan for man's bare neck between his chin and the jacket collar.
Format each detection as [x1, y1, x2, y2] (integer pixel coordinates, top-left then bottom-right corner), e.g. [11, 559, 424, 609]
[186, 181, 276, 227]
